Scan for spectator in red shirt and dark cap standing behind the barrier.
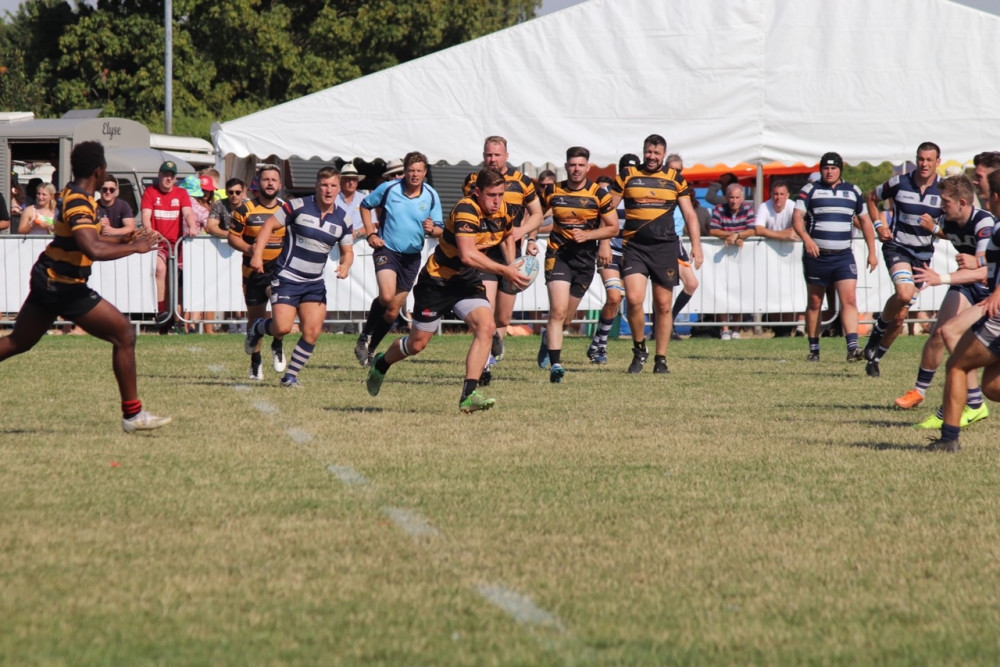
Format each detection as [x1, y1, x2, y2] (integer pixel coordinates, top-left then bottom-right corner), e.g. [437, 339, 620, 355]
[141, 160, 199, 333]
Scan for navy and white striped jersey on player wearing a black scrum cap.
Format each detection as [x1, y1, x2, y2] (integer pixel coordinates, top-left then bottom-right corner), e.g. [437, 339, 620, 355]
[795, 181, 865, 252]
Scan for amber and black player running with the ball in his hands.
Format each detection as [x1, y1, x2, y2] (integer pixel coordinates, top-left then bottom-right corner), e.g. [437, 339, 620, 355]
[366, 169, 529, 413]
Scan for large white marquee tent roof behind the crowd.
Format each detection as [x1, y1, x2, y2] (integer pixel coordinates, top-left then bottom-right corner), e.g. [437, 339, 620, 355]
[213, 0, 1000, 164]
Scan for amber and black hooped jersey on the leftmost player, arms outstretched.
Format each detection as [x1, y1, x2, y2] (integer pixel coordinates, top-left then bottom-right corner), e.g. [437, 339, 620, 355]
[38, 183, 100, 284]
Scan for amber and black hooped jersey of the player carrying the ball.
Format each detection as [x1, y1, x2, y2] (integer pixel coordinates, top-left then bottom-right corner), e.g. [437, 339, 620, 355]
[424, 197, 514, 281]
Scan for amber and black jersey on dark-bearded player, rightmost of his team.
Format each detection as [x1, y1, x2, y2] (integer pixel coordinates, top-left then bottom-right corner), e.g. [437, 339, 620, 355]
[611, 167, 691, 245]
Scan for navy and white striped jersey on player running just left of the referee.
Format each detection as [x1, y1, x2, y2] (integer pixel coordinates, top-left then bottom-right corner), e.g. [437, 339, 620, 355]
[274, 195, 354, 283]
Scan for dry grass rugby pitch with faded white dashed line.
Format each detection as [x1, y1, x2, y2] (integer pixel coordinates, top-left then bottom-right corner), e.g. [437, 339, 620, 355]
[0, 336, 1000, 665]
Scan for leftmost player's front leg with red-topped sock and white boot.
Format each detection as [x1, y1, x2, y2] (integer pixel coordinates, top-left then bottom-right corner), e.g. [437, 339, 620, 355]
[71, 299, 171, 433]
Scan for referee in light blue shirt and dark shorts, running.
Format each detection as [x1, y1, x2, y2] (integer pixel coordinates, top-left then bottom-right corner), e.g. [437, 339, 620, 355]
[354, 151, 444, 367]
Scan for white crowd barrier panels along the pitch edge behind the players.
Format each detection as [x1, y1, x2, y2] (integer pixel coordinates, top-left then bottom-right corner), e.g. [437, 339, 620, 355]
[0, 235, 955, 327]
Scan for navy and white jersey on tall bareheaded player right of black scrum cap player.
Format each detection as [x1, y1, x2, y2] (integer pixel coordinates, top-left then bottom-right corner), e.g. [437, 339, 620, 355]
[875, 171, 941, 262]
